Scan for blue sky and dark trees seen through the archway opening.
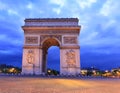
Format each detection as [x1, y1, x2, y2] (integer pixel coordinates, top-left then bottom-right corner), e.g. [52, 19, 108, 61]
[47, 46, 60, 75]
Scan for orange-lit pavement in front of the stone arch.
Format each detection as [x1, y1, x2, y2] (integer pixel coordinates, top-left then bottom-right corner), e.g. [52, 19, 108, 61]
[0, 75, 120, 93]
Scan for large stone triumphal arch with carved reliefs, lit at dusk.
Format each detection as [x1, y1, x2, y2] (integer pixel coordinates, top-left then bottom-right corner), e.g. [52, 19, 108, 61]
[22, 18, 81, 75]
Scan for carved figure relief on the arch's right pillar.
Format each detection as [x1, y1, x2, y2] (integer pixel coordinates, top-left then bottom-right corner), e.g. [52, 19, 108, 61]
[66, 49, 76, 67]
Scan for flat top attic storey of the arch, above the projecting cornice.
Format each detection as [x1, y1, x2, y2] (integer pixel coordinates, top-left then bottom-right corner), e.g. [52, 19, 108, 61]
[24, 18, 79, 27]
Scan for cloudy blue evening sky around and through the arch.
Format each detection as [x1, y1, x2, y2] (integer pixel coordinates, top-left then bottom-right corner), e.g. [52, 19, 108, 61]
[0, 0, 120, 69]
